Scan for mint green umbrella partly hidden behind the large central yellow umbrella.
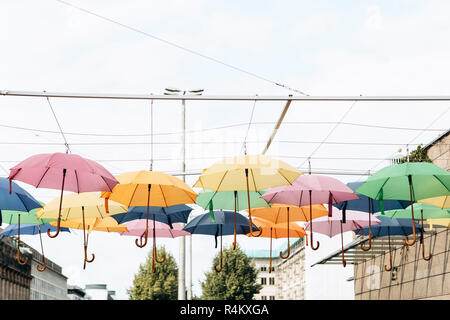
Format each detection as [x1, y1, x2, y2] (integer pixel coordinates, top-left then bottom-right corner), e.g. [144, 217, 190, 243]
[197, 190, 269, 250]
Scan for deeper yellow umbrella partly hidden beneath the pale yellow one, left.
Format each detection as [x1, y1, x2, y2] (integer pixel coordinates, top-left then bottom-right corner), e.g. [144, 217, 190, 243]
[50, 217, 128, 269]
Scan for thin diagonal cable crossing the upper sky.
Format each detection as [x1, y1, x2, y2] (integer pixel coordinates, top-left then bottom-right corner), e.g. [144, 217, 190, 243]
[51, 0, 307, 96]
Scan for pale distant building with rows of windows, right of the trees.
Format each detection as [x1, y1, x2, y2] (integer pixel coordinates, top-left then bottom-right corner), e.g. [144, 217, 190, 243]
[245, 238, 305, 300]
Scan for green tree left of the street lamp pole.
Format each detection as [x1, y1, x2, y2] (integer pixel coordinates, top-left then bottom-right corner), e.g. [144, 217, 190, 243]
[128, 247, 178, 300]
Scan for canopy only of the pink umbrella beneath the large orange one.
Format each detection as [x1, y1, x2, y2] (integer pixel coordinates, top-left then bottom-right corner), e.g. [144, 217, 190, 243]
[120, 219, 190, 238]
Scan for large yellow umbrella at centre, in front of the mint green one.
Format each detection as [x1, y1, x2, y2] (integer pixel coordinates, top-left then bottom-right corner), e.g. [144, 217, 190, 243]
[194, 155, 302, 236]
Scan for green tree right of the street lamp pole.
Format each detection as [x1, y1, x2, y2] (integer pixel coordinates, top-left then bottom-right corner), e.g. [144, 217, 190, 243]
[201, 245, 262, 300]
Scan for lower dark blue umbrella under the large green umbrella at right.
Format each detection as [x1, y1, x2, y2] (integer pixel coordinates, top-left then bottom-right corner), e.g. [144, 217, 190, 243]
[354, 216, 423, 271]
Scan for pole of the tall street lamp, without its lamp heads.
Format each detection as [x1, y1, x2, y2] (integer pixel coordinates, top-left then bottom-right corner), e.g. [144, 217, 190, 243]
[178, 96, 186, 300]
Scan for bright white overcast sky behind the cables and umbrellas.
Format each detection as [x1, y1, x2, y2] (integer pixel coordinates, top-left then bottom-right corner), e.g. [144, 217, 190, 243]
[0, 0, 450, 299]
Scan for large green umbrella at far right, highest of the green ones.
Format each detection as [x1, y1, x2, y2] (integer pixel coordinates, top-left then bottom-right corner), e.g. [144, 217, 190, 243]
[356, 162, 450, 246]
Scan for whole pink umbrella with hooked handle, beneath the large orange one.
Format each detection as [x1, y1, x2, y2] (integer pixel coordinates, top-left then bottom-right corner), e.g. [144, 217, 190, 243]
[120, 219, 190, 273]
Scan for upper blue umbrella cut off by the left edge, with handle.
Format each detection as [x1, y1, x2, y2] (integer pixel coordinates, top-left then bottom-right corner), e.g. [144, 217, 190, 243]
[0, 178, 41, 266]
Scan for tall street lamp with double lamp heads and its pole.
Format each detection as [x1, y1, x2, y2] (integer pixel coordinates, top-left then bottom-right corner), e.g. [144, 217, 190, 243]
[164, 88, 203, 300]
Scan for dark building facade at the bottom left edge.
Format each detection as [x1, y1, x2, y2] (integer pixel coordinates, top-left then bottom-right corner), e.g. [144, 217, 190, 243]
[0, 237, 32, 300]
